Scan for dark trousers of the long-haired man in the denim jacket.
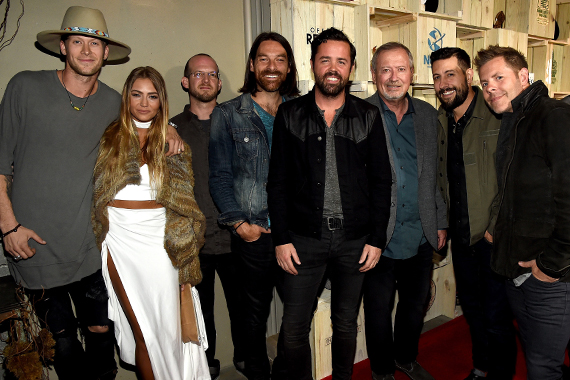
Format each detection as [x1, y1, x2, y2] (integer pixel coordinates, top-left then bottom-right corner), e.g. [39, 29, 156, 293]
[232, 233, 282, 380]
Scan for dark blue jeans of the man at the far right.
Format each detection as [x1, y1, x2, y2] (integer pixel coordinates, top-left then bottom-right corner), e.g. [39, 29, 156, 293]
[507, 276, 570, 380]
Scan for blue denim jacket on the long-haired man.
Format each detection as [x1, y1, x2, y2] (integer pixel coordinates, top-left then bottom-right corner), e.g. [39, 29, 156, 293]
[209, 94, 270, 228]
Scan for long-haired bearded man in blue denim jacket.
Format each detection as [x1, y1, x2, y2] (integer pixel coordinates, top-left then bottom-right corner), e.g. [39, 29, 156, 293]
[209, 32, 299, 380]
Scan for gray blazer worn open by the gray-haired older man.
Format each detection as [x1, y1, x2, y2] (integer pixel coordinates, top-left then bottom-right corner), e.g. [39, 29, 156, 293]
[366, 92, 447, 248]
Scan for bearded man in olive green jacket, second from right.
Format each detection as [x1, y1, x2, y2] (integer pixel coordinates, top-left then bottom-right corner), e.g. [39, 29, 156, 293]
[431, 48, 516, 380]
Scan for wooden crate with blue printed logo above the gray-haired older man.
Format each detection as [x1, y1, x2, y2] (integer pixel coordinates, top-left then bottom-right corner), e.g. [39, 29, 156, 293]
[370, 13, 459, 84]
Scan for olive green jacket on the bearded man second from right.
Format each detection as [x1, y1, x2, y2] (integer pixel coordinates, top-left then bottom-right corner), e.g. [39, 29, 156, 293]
[437, 88, 501, 245]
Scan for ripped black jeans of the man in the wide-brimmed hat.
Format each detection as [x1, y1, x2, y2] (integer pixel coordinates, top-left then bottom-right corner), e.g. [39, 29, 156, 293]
[26, 270, 117, 380]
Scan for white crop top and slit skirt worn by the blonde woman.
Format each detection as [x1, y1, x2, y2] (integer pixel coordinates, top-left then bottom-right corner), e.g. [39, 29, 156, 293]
[101, 165, 210, 380]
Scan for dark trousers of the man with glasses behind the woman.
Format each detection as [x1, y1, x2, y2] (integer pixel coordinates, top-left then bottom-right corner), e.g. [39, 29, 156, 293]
[196, 253, 245, 367]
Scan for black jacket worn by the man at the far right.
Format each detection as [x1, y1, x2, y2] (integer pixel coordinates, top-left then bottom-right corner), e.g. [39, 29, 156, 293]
[491, 81, 570, 282]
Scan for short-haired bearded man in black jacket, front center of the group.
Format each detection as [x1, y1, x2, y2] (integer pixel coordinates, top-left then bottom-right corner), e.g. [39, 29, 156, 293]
[267, 28, 392, 380]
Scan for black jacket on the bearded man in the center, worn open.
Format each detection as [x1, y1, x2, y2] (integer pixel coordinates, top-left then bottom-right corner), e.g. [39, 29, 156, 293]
[267, 91, 392, 249]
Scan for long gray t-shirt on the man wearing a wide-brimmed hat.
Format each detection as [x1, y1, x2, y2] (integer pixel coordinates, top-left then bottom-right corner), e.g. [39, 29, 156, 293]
[0, 71, 121, 289]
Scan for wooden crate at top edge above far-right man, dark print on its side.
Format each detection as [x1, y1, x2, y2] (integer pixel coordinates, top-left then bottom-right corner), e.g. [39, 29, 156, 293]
[500, 0, 556, 38]
